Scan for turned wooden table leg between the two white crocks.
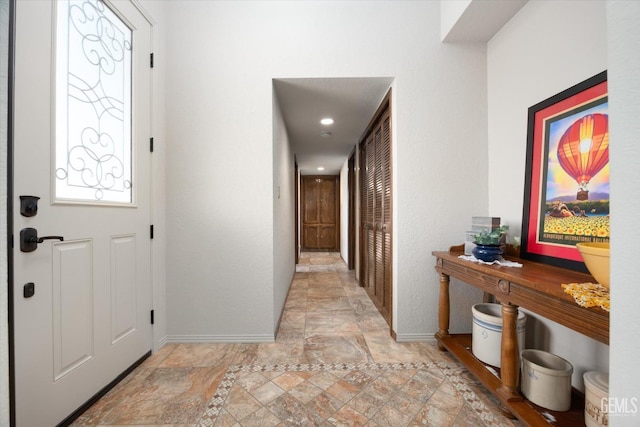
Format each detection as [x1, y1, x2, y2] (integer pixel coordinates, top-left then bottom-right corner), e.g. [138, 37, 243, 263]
[498, 303, 522, 401]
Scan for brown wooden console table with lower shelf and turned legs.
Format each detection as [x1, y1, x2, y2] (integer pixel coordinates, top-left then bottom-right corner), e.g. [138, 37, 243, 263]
[433, 246, 609, 426]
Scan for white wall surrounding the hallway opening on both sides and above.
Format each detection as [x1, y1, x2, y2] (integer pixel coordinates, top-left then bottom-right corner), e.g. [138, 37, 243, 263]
[166, 1, 487, 341]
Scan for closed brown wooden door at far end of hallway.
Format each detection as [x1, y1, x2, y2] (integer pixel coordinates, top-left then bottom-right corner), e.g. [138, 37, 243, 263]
[302, 176, 340, 252]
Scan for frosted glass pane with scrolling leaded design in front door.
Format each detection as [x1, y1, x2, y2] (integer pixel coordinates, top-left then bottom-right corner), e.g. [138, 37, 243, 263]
[54, 0, 133, 204]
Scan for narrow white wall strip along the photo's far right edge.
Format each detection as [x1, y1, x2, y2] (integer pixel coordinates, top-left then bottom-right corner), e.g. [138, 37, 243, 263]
[607, 1, 640, 427]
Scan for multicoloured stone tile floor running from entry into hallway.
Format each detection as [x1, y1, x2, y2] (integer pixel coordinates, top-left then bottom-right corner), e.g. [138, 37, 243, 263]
[73, 253, 519, 427]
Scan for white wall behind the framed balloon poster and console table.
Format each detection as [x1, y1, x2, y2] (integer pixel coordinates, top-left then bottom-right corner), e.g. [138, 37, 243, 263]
[487, 1, 617, 389]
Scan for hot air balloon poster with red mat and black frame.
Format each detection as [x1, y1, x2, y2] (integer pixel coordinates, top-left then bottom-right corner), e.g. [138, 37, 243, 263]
[520, 71, 610, 272]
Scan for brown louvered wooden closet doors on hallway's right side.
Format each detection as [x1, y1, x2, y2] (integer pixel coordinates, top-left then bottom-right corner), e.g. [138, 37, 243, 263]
[360, 96, 392, 324]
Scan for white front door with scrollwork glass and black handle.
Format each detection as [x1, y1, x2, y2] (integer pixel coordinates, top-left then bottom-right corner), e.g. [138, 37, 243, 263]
[13, 0, 152, 427]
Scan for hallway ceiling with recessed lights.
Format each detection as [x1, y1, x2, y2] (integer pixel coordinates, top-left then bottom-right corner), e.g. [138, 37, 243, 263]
[273, 77, 393, 175]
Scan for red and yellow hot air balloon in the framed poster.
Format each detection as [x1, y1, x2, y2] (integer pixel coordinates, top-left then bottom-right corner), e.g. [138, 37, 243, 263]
[558, 114, 609, 200]
